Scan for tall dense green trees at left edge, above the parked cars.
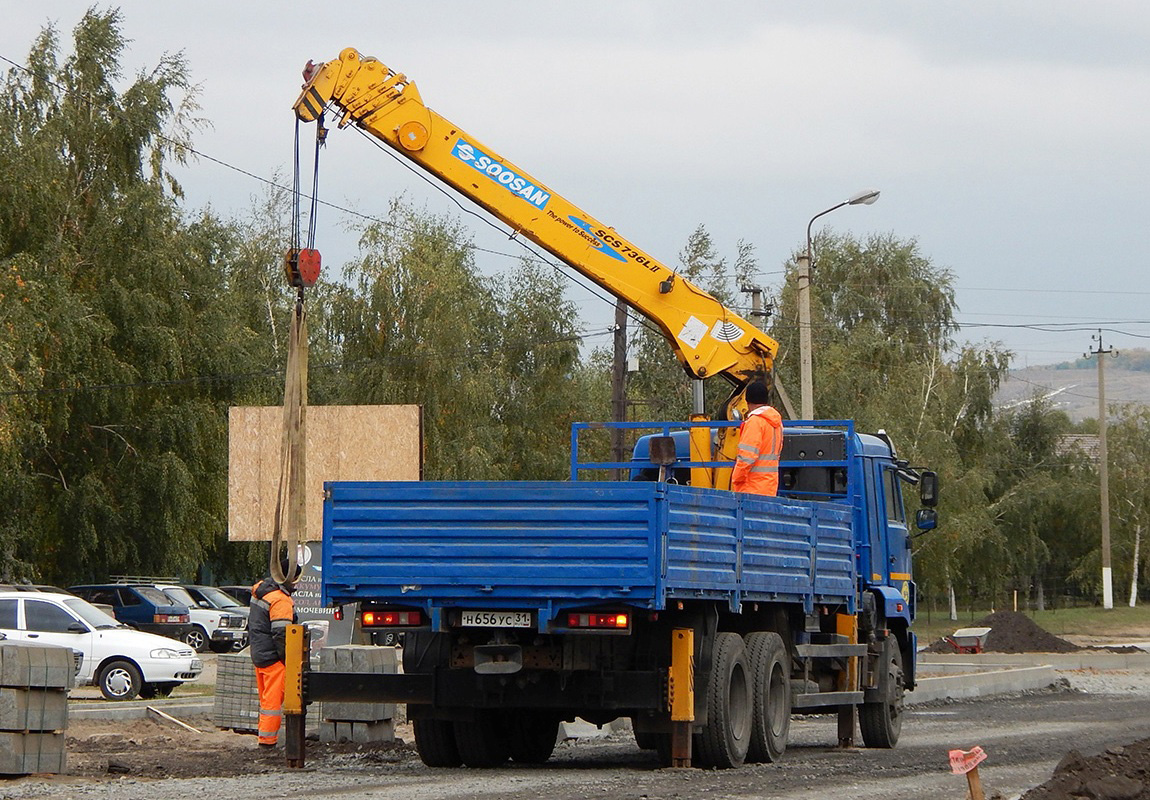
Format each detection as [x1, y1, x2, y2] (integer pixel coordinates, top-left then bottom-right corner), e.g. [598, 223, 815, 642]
[0, 10, 278, 582]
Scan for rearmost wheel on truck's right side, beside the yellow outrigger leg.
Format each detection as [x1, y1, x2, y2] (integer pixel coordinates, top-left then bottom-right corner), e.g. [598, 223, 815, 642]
[695, 633, 752, 769]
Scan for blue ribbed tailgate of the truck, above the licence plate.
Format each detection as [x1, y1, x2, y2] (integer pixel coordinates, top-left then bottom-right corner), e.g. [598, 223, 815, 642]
[323, 482, 660, 607]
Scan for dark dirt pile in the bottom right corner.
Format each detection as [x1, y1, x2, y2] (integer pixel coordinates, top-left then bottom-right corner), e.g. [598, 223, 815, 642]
[1021, 739, 1150, 800]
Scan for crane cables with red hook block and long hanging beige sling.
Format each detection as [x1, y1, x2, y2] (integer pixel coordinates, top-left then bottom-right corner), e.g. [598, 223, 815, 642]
[268, 115, 327, 584]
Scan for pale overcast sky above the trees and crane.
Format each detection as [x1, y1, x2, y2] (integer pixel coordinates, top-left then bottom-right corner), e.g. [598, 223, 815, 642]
[0, 0, 1150, 366]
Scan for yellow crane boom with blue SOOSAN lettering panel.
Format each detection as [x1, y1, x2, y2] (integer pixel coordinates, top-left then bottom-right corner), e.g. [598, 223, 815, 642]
[294, 47, 779, 393]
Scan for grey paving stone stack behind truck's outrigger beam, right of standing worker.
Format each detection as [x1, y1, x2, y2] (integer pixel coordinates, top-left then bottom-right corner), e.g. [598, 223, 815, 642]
[317, 645, 396, 744]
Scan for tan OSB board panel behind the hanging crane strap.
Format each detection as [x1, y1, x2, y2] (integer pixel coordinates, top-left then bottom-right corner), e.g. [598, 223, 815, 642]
[228, 406, 422, 541]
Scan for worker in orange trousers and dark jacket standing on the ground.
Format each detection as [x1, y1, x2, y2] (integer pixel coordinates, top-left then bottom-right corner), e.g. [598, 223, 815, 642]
[247, 559, 298, 747]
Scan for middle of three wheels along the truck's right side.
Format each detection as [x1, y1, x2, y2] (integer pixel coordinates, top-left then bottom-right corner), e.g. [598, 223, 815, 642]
[746, 632, 790, 763]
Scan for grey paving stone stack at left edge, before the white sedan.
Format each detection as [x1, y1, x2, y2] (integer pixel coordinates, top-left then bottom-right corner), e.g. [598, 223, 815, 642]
[0, 641, 75, 775]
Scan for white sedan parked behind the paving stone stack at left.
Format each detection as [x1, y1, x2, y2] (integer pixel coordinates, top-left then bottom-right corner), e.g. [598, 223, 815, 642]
[0, 592, 204, 700]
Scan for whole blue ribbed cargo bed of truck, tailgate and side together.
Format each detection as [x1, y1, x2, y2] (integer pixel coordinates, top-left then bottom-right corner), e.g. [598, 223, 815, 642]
[323, 482, 856, 623]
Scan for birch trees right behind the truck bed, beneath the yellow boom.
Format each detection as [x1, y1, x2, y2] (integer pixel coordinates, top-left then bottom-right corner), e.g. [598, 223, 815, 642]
[321, 202, 593, 480]
